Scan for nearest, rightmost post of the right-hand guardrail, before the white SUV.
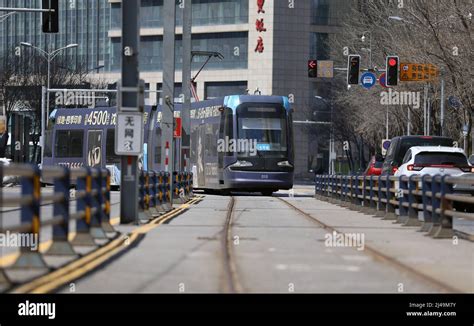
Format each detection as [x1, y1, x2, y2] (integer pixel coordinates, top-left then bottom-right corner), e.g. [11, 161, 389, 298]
[430, 175, 454, 239]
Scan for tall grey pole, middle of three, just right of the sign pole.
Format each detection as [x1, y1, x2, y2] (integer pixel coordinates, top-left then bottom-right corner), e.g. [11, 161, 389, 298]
[161, 1, 178, 203]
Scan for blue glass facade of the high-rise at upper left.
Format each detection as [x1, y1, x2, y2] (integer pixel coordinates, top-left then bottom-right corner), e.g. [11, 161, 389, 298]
[0, 0, 110, 69]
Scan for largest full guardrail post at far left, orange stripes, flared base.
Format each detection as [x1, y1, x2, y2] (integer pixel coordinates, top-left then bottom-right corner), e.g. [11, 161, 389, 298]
[9, 165, 48, 269]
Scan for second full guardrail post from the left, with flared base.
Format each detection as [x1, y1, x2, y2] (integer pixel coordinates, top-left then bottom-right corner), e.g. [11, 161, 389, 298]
[45, 167, 77, 256]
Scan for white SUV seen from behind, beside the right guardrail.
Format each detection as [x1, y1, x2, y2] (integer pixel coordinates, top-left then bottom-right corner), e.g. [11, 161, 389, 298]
[395, 146, 474, 176]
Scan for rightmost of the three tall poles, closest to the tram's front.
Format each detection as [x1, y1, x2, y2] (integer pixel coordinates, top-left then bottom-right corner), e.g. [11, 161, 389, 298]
[180, 0, 192, 170]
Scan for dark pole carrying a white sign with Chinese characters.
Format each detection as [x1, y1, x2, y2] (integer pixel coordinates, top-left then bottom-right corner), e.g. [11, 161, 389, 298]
[115, 1, 145, 223]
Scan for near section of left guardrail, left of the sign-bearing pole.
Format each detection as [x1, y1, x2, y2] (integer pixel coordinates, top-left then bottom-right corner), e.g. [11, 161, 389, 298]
[0, 165, 114, 285]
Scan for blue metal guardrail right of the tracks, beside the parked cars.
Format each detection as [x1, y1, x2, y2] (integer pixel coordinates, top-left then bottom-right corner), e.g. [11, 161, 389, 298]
[315, 175, 474, 238]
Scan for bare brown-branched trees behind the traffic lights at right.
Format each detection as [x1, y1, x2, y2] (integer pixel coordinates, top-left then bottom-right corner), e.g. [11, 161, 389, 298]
[332, 0, 474, 160]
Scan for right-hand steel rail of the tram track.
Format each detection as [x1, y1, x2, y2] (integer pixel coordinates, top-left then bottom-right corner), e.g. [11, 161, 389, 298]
[275, 197, 463, 293]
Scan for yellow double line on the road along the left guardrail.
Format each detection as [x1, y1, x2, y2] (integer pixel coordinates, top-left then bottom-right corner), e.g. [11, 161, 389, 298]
[11, 197, 203, 294]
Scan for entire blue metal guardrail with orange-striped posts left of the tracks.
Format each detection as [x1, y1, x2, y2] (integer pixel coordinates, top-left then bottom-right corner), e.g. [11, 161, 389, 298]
[0, 165, 193, 285]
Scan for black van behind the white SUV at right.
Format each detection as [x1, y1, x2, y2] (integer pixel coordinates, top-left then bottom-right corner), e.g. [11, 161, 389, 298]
[382, 136, 454, 175]
